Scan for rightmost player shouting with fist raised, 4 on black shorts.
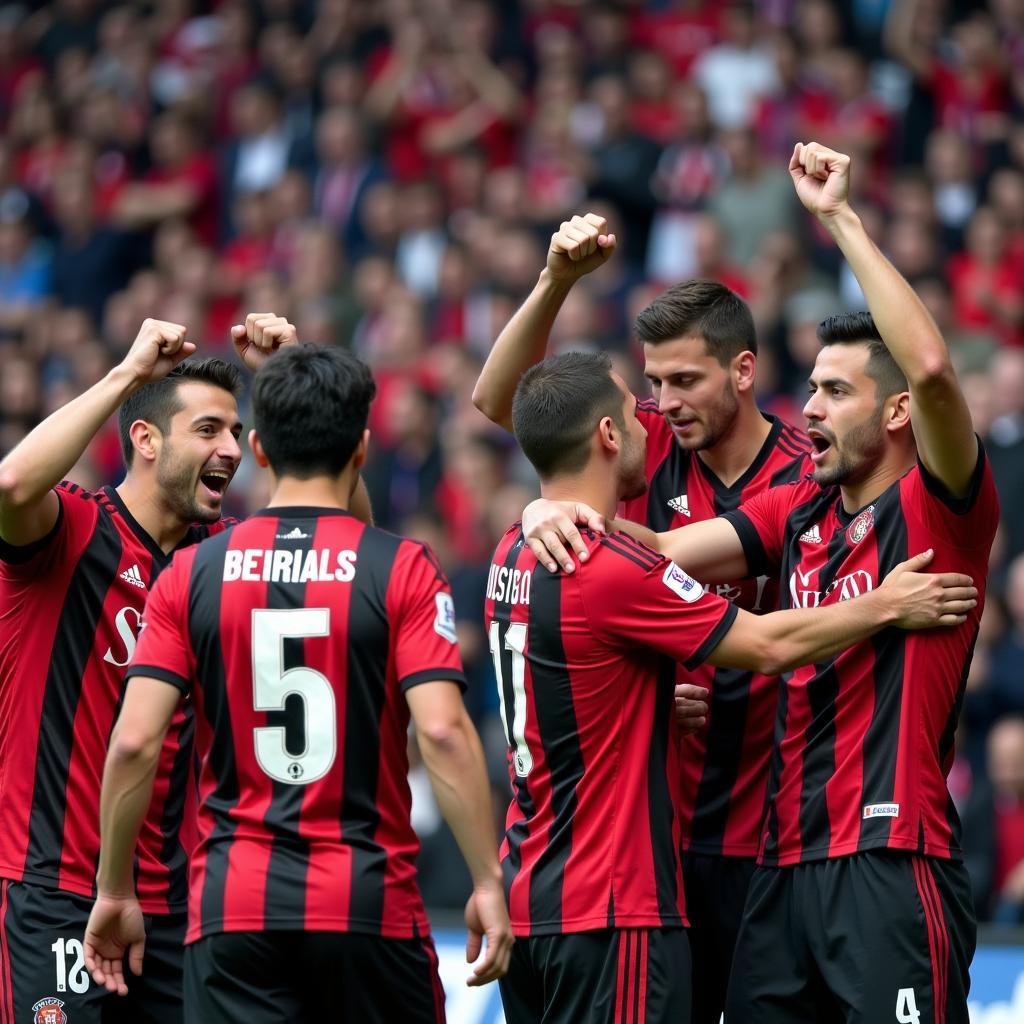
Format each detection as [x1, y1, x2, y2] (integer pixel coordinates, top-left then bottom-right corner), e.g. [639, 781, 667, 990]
[535, 142, 998, 1024]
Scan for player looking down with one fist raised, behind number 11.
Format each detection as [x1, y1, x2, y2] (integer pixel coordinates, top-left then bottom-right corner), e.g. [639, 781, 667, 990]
[473, 214, 813, 1024]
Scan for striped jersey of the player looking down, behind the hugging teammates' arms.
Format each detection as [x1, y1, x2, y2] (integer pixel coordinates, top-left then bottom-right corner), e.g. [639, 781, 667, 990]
[624, 400, 813, 857]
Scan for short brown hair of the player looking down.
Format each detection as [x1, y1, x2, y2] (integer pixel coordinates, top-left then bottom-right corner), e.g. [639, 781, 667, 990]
[635, 281, 758, 367]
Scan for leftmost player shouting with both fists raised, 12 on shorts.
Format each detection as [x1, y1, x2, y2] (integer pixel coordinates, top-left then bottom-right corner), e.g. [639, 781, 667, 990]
[0, 313, 295, 1024]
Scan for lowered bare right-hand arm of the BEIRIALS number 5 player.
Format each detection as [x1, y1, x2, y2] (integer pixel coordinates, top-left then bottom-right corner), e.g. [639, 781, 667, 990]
[406, 682, 513, 985]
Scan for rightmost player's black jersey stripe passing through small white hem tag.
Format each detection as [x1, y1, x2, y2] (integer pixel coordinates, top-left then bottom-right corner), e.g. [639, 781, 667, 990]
[859, 486, 909, 846]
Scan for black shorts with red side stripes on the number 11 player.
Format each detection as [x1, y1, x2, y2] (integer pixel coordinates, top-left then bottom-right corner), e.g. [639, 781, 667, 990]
[499, 928, 690, 1024]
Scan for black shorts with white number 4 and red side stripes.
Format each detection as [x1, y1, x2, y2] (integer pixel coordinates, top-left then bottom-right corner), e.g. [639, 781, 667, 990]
[725, 851, 976, 1024]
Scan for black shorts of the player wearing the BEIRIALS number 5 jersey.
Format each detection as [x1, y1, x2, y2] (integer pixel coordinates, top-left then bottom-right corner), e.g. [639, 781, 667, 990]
[185, 931, 444, 1024]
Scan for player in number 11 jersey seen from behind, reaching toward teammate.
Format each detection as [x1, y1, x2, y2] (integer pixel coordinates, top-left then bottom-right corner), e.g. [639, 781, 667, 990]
[487, 353, 974, 1024]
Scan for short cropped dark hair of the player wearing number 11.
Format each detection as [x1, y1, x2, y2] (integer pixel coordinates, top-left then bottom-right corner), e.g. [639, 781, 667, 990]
[512, 352, 626, 480]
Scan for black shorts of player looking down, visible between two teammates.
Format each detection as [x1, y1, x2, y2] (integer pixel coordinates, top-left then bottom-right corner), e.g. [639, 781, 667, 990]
[682, 853, 755, 1024]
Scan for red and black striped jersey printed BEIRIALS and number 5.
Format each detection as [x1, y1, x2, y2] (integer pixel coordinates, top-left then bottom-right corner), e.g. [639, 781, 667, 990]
[128, 507, 464, 942]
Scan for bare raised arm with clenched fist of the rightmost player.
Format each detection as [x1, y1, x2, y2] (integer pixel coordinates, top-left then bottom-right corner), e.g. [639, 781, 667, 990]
[790, 142, 978, 498]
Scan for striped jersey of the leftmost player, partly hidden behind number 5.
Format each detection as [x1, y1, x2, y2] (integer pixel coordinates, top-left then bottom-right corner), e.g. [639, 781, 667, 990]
[0, 482, 223, 913]
